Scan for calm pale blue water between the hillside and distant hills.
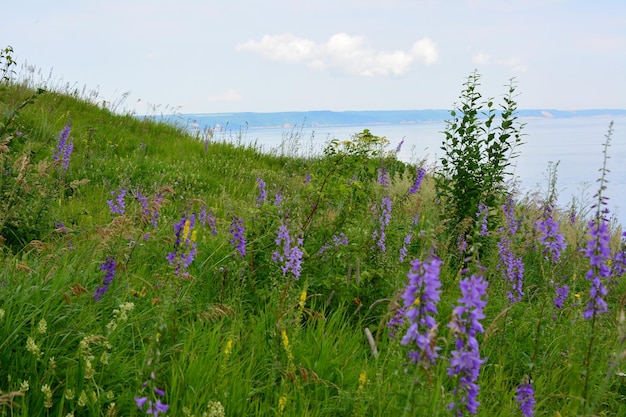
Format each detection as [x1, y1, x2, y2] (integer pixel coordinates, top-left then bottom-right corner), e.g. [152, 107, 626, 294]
[205, 116, 626, 225]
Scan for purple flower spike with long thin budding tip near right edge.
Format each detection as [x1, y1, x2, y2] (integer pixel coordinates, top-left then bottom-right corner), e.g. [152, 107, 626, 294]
[583, 216, 611, 319]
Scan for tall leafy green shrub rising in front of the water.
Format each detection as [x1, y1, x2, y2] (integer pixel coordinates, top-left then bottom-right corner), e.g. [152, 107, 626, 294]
[435, 72, 524, 234]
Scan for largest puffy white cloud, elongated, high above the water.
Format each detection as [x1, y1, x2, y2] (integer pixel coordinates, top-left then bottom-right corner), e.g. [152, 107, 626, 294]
[237, 33, 439, 77]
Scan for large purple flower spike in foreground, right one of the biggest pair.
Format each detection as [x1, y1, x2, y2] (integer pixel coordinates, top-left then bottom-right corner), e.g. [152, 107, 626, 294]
[448, 275, 487, 416]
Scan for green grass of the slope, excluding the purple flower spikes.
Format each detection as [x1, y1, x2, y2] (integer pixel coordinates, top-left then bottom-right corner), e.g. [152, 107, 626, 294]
[0, 86, 626, 416]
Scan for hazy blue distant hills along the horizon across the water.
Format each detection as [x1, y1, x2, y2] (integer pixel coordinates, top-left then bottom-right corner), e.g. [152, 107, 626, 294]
[159, 109, 626, 130]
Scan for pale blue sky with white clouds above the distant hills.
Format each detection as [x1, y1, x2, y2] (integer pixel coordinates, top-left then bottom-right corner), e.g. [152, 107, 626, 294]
[0, 0, 626, 114]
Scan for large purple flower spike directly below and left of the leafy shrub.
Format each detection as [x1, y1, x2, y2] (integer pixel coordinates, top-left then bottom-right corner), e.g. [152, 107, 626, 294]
[400, 255, 442, 364]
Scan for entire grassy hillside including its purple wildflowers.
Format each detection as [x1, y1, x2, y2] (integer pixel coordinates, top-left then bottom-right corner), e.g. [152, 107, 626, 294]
[0, 62, 626, 416]
